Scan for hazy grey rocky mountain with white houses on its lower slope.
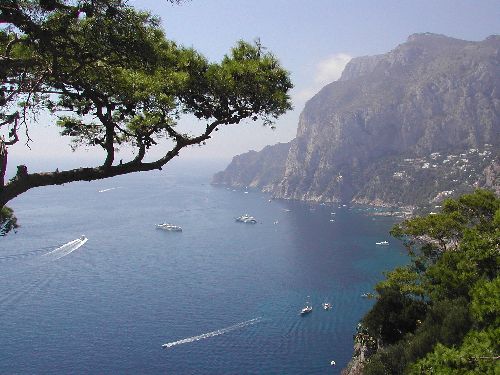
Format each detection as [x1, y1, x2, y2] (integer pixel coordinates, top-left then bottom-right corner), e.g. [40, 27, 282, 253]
[214, 33, 500, 205]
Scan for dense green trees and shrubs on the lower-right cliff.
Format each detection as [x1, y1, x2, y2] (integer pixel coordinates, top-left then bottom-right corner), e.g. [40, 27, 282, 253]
[356, 190, 500, 375]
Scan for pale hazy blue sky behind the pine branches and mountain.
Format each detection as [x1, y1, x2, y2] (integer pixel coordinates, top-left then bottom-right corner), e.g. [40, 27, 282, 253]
[4, 0, 500, 170]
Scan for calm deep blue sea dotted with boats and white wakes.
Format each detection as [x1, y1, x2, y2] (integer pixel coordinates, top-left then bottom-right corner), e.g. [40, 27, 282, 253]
[0, 162, 407, 374]
